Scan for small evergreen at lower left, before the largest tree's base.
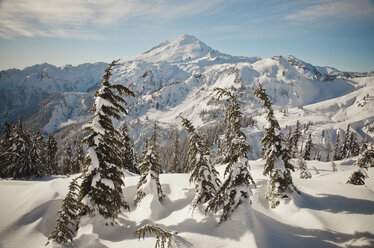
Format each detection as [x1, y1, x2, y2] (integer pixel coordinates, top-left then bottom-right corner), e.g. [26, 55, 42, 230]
[46, 178, 83, 245]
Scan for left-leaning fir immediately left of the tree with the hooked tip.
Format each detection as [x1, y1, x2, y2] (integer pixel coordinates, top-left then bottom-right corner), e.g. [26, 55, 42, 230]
[179, 115, 220, 209]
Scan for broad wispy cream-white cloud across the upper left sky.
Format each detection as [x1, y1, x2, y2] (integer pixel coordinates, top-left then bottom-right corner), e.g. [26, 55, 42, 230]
[0, 0, 222, 39]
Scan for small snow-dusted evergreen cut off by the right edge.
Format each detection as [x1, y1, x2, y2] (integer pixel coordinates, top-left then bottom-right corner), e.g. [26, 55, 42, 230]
[347, 141, 374, 185]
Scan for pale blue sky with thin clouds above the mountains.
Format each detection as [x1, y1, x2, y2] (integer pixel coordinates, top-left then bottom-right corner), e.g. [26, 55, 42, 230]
[0, 0, 374, 71]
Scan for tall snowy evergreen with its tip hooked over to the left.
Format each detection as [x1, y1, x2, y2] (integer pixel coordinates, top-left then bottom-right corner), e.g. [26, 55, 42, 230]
[206, 88, 254, 222]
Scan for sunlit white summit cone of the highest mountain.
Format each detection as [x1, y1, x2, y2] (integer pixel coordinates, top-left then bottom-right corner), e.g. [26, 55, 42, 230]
[136, 34, 219, 62]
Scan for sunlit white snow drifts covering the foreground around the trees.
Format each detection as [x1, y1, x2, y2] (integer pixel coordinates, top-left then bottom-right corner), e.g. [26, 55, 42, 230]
[0, 157, 374, 248]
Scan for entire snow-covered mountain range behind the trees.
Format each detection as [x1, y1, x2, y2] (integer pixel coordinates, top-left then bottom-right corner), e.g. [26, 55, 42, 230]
[0, 35, 374, 158]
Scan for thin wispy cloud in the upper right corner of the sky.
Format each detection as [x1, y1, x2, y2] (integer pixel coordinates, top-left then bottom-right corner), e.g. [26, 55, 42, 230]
[285, 0, 374, 22]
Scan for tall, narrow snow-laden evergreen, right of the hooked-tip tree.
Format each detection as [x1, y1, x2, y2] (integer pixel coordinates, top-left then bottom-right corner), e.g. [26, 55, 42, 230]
[254, 84, 298, 208]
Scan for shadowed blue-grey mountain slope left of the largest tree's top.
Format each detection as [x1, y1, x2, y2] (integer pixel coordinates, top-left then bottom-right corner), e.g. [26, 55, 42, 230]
[0, 63, 107, 125]
